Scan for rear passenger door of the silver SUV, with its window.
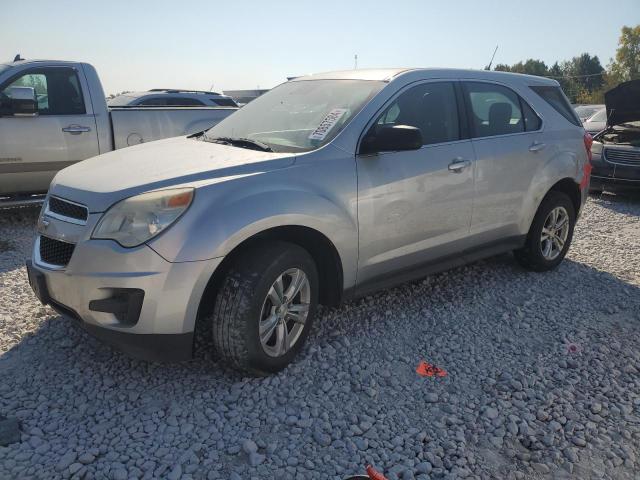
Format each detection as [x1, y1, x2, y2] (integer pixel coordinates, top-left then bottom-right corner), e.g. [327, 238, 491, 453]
[463, 81, 551, 245]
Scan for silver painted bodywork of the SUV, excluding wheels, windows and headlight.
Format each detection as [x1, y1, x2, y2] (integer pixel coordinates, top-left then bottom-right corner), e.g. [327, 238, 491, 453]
[29, 69, 587, 359]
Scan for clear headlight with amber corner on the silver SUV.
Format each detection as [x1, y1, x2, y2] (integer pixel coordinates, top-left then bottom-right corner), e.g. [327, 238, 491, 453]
[91, 188, 193, 247]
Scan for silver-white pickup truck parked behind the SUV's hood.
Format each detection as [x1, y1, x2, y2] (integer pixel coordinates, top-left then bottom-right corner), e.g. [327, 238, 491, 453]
[0, 60, 237, 204]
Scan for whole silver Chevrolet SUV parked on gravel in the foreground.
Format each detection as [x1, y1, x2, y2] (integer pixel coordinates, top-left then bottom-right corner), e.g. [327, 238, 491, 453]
[27, 69, 591, 375]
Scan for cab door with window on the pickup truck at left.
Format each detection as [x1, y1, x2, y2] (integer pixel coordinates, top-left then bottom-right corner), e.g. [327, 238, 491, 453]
[0, 66, 99, 194]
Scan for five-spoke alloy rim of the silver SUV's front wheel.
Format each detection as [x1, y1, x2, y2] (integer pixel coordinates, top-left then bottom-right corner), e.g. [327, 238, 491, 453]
[258, 268, 311, 357]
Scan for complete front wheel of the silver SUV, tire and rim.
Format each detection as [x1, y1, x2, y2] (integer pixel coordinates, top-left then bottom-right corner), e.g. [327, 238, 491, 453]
[211, 242, 318, 375]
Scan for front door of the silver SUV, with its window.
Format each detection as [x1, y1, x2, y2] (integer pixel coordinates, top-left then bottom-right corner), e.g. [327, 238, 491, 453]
[357, 81, 475, 286]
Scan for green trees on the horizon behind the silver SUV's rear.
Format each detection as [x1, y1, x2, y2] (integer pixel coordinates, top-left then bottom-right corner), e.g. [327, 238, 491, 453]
[494, 25, 640, 103]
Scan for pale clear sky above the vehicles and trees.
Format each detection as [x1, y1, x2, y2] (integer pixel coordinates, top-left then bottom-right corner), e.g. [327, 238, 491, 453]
[0, 0, 640, 94]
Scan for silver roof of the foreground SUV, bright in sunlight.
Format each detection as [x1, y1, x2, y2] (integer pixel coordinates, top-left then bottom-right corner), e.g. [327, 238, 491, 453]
[291, 68, 558, 85]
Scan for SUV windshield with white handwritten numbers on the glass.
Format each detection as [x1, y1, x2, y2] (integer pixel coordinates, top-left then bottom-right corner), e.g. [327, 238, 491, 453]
[204, 80, 385, 152]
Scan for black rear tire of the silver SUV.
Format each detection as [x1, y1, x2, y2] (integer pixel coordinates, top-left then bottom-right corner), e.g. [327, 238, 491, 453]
[513, 190, 576, 272]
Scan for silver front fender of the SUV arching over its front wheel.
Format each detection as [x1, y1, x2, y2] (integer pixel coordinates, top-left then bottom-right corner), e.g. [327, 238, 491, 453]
[149, 169, 358, 286]
